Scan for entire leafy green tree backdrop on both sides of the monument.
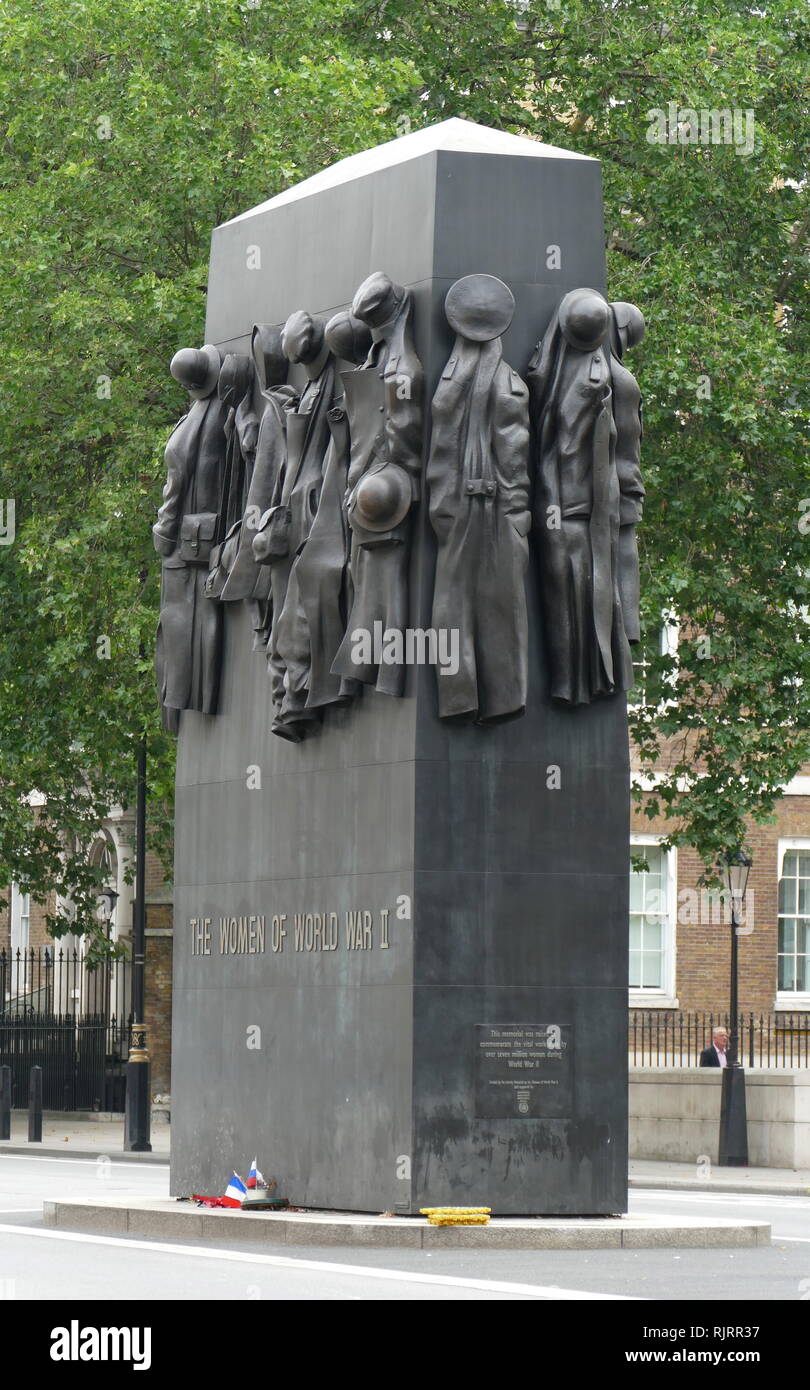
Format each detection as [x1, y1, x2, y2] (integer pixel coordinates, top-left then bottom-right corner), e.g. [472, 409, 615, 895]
[0, 0, 810, 931]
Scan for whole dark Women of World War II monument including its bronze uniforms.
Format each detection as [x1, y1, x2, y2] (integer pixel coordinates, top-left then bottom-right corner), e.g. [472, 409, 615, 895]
[163, 120, 643, 1215]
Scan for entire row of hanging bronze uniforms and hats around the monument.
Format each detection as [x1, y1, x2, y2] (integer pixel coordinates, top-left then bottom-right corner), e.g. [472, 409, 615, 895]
[154, 271, 645, 742]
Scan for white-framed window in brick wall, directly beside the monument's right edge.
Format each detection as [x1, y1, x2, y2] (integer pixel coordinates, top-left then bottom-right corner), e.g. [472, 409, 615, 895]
[629, 834, 678, 1009]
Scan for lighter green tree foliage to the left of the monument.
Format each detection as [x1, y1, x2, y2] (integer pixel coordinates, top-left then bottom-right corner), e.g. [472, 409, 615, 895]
[0, 0, 414, 933]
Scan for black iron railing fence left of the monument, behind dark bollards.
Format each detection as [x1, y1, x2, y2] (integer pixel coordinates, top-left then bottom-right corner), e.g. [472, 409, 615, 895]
[0, 947, 132, 1111]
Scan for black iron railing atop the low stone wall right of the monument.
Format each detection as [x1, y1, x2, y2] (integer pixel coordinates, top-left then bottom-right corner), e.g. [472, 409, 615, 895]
[628, 1009, 810, 1070]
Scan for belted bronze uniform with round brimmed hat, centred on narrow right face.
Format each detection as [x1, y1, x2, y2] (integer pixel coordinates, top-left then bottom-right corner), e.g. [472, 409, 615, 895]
[427, 275, 531, 723]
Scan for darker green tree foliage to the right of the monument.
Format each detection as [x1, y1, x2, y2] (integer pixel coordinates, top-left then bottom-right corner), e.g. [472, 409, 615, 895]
[341, 0, 810, 866]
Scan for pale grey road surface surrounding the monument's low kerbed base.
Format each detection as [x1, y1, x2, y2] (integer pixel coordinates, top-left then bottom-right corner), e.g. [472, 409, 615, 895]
[0, 1151, 810, 1295]
